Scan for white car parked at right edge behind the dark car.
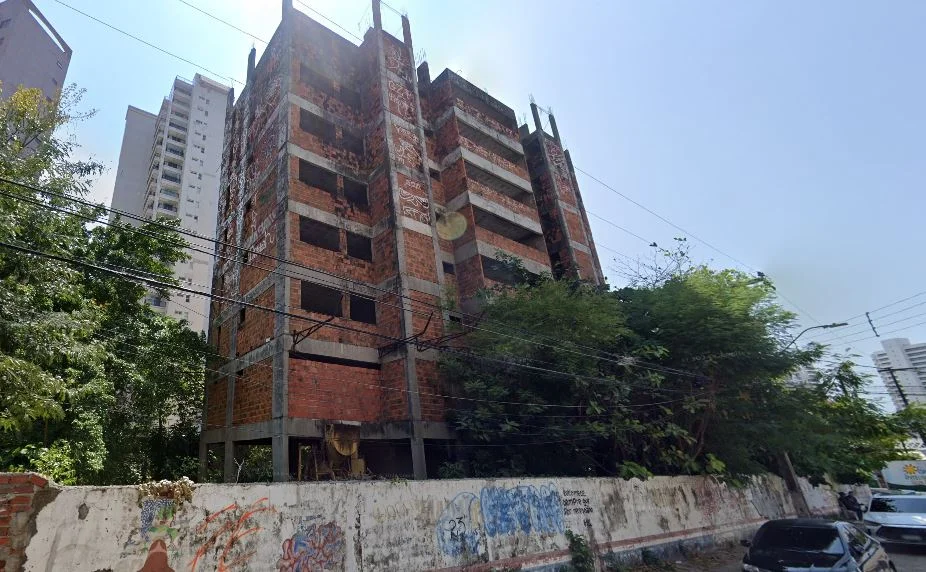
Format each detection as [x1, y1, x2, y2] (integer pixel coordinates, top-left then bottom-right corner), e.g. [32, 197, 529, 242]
[865, 494, 926, 545]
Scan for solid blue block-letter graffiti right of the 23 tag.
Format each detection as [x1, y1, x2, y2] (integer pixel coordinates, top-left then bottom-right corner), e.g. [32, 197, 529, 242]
[479, 485, 565, 537]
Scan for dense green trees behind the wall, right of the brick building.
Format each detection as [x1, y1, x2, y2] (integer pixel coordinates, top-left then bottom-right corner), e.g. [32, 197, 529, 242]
[442, 246, 926, 482]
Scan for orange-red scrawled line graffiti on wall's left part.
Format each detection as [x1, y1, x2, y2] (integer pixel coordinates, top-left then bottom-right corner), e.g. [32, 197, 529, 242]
[190, 497, 276, 572]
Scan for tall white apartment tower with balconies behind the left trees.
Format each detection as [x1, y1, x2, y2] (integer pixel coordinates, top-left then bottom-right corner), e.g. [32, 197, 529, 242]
[112, 74, 232, 331]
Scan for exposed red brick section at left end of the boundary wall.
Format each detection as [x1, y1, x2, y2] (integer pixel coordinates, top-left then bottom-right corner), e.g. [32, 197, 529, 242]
[0, 473, 58, 572]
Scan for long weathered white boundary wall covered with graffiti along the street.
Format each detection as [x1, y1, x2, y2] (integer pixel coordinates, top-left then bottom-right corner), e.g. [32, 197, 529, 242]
[0, 475, 856, 572]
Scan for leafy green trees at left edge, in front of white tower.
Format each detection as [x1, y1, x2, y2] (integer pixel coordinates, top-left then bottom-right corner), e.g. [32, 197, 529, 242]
[0, 87, 207, 484]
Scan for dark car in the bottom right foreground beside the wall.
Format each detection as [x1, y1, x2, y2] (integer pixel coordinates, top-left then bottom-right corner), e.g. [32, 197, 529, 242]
[743, 518, 896, 572]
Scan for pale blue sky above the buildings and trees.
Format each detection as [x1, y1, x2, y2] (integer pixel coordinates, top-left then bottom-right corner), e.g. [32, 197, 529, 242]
[35, 0, 926, 404]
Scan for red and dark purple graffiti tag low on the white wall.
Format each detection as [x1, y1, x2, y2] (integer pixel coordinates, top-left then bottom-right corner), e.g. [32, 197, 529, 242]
[277, 522, 346, 572]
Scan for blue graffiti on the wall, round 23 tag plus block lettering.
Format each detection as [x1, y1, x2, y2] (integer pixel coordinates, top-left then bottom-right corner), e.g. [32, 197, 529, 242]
[436, 484, 566, 556]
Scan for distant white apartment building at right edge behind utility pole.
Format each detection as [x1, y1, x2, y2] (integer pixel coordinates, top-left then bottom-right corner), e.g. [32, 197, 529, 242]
[871, 338, 926, 409]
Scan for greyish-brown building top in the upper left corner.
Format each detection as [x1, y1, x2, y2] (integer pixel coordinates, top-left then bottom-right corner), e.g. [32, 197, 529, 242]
[0, 0, 71, 99]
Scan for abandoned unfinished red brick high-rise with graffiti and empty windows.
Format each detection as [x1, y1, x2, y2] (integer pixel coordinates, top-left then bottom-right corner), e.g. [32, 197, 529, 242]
[200, 0, 603, 480]
